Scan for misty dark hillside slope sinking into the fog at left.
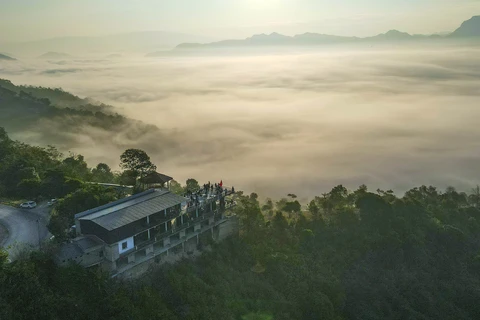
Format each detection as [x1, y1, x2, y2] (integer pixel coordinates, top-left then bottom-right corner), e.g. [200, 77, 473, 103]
[0, 79, 161, 154]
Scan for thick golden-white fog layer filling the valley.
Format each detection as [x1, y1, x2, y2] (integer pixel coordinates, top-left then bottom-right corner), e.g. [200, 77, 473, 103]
[0, 45, 480, 197]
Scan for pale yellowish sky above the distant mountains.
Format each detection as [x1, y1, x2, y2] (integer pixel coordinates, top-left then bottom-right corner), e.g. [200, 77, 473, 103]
[0, 0, 480, 43]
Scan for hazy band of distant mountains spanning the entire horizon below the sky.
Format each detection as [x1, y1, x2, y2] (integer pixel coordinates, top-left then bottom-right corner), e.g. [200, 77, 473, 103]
[0, 16, 480, 60]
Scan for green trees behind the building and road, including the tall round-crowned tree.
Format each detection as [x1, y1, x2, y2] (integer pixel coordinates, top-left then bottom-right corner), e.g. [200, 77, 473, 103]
[0, 127, 168, 240]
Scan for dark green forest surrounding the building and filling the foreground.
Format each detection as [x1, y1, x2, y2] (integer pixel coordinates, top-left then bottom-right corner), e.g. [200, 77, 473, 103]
[0, 131, 480, 320]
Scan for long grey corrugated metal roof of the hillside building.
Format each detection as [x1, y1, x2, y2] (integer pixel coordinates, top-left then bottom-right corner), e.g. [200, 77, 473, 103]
[80, 190, 187, 231]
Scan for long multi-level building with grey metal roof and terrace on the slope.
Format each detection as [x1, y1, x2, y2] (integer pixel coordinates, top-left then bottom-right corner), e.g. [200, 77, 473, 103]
[65, 185, 238, 275]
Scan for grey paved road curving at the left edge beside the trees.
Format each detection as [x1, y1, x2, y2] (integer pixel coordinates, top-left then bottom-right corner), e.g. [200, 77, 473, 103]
[0, 204, 50, 259]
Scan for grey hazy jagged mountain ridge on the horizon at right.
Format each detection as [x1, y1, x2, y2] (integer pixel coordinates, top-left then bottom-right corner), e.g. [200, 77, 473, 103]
[153, 16, 480, 56]
